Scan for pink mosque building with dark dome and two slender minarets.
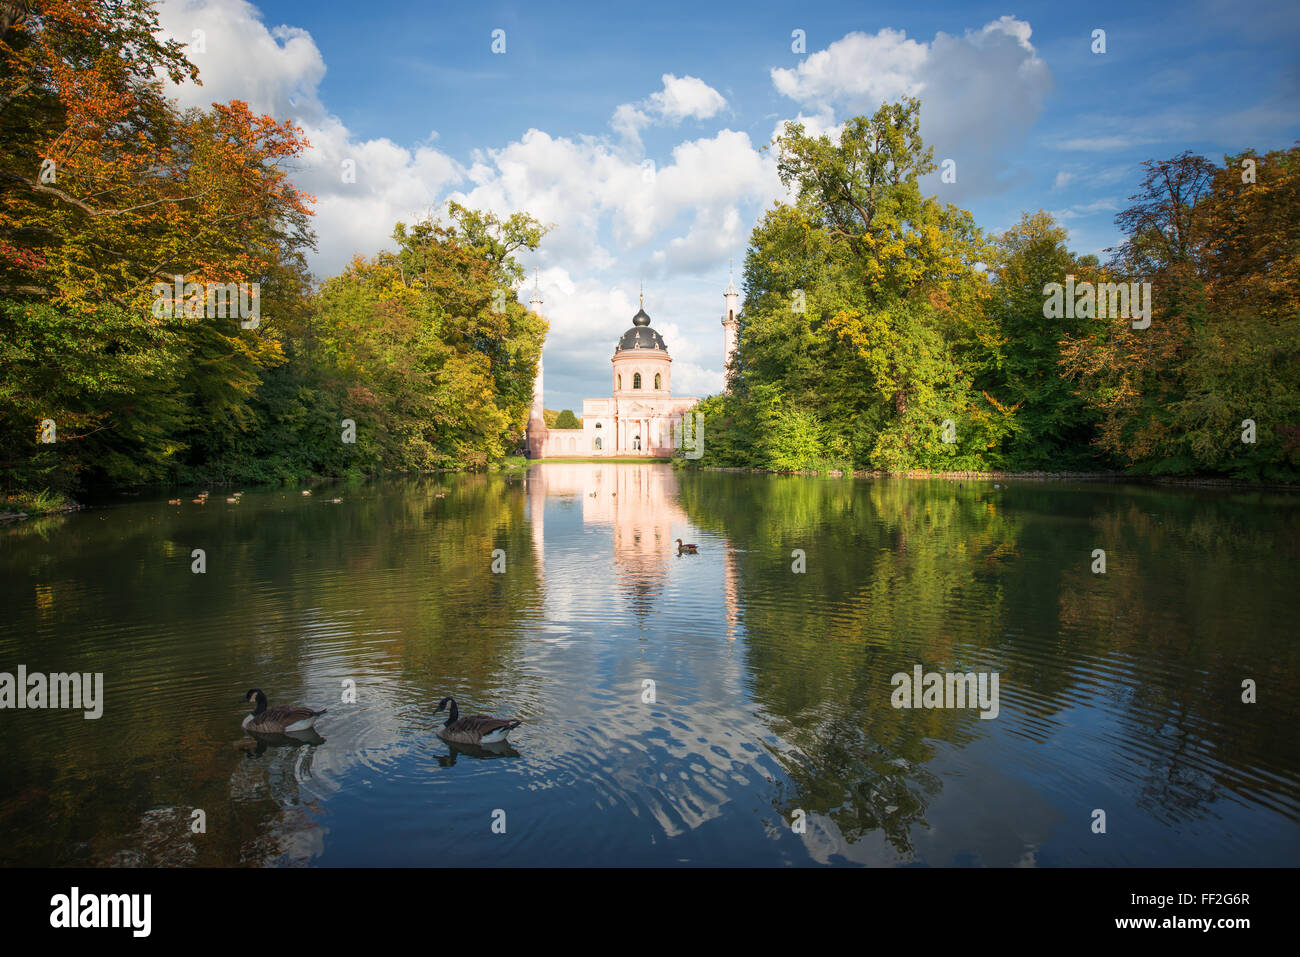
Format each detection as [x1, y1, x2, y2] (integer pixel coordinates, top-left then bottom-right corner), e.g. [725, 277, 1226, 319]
[528, 273, 740, 459]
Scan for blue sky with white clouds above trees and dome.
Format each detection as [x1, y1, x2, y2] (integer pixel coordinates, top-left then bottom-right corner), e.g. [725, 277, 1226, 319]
[160, 0, 1300, 412]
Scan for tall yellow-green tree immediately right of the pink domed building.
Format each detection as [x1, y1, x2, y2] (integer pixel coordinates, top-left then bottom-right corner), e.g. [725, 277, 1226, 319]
[735, 99, 1010, 469]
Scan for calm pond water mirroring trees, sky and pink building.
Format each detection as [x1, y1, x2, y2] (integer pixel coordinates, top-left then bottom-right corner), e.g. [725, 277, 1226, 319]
[0, 464, 1300, 866]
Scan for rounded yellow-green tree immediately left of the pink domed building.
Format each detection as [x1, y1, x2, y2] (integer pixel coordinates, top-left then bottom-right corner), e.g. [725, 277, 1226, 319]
[312, 213, 546, 471]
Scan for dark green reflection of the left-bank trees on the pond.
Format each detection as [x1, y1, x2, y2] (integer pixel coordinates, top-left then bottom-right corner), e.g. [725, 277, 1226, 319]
[0, 476, 541, 866]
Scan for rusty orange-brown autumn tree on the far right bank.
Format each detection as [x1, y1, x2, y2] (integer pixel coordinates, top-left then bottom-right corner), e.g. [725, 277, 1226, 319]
[1062, 147, 1300, 481]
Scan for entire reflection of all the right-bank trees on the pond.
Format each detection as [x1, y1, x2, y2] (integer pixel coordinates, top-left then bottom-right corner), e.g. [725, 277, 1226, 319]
[683, 475, 1300, 854]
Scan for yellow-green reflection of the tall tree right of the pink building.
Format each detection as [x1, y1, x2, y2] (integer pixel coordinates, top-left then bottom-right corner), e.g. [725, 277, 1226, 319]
[683, 476, 1021, 856]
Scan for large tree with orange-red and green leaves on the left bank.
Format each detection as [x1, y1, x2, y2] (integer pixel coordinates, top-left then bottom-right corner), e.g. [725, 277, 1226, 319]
[0, 0, 312, 485]
